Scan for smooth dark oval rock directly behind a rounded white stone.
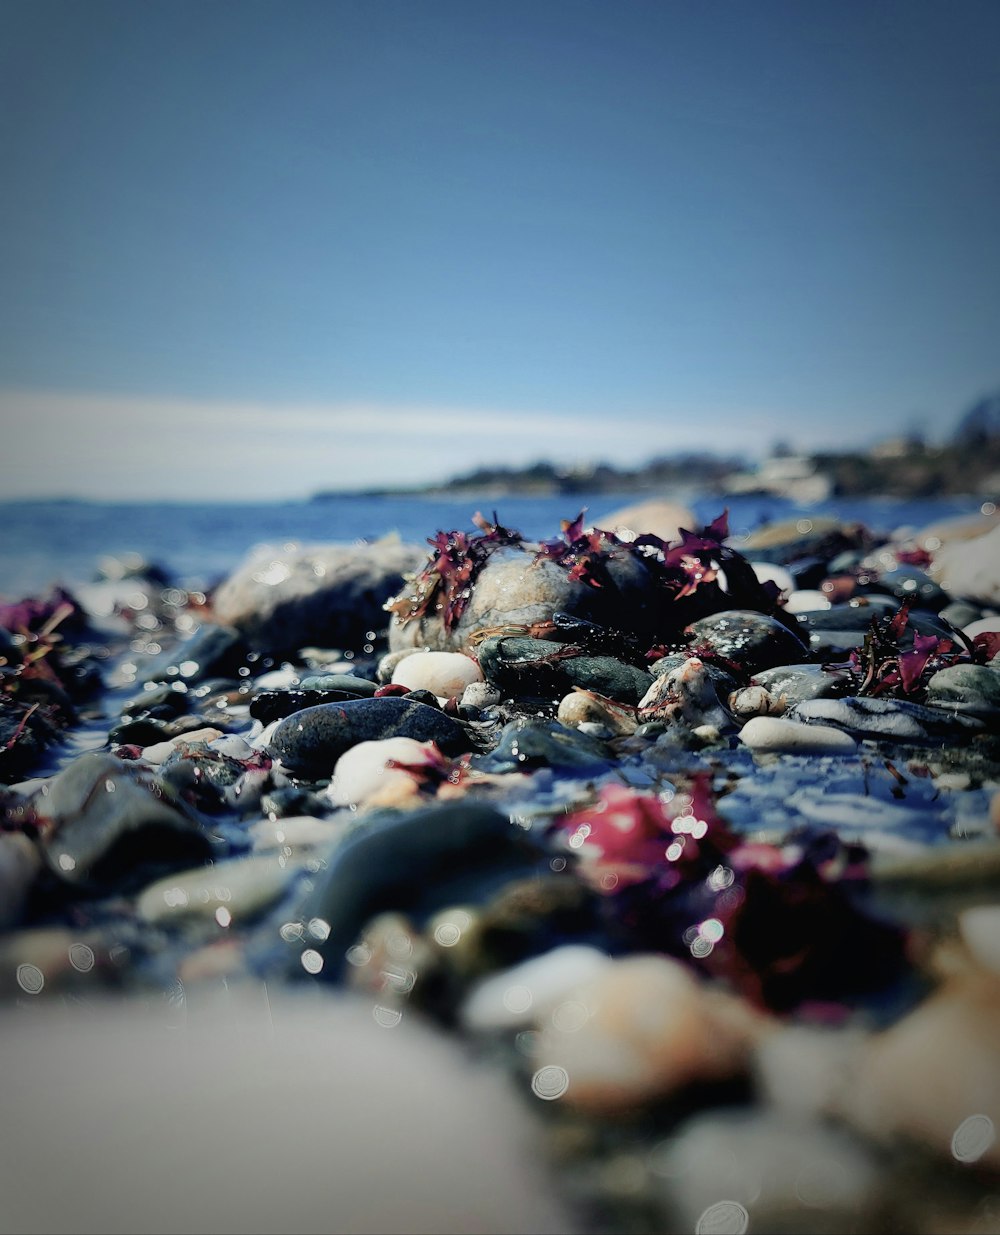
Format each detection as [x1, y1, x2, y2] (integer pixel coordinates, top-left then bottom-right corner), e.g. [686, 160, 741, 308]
[269, 697, 469, 777]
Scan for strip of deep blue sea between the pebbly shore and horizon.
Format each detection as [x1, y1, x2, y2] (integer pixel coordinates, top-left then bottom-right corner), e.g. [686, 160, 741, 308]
[0, 493, 981, 600]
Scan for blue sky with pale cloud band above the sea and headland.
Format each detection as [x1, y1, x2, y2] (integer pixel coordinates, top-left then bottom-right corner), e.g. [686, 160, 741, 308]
[0, 0, 1000, 498]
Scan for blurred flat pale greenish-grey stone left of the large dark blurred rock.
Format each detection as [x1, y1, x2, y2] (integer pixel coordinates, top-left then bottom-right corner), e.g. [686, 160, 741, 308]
[136, 853, 304, 930]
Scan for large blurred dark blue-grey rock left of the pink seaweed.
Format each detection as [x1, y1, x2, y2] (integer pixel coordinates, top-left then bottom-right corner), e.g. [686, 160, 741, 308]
[280, 802, 543, 982]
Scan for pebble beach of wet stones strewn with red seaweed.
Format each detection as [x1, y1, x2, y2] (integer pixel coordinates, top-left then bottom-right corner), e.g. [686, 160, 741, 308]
[0, 503, 1000, 1235]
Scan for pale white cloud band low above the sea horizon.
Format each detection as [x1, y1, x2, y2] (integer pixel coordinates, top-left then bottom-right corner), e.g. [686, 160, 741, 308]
[0, 390, 769, 500]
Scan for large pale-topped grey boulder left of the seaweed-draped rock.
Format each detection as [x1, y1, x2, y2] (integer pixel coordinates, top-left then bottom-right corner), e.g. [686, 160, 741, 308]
[212, 537, 425, 653]
